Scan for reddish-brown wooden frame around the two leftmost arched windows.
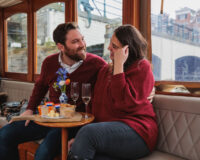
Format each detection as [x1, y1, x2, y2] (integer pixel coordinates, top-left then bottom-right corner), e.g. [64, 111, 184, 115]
[0, 0, 78, 82]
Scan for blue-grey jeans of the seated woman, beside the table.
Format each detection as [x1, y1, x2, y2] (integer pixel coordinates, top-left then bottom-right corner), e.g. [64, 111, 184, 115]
[71, 122, 150, 160]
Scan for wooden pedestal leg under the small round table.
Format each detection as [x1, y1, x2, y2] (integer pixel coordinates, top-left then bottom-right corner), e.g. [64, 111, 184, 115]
[62, 128, 68, 160]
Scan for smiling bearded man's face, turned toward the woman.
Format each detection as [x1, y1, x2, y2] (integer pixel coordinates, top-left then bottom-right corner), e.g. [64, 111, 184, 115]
[63, 29, 86, 61]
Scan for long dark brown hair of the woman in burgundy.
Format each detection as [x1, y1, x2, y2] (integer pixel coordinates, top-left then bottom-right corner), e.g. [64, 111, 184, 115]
[114, 24, 147, 71]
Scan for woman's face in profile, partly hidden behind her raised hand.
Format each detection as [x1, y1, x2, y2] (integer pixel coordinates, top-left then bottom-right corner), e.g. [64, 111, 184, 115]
[108, 34, 123, 61]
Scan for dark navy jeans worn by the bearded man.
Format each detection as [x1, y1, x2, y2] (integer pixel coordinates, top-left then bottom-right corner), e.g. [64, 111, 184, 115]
[0, 121, 78, 160]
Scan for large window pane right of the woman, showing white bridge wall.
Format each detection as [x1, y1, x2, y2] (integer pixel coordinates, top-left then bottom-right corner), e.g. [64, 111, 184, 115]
[151, 0, 200, 82]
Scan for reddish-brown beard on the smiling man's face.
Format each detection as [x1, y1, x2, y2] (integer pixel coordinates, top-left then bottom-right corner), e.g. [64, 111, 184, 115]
[64, 46, 86, 62]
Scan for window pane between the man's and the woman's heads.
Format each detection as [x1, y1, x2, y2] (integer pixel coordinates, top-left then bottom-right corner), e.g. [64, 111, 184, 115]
[78, 0, 122, 61]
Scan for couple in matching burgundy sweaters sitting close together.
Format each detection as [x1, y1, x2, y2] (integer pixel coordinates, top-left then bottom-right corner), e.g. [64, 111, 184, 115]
[0, 23, 158, 160]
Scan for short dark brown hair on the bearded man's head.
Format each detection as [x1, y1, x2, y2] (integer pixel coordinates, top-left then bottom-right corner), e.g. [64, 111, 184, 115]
[53, 22, 79, 45]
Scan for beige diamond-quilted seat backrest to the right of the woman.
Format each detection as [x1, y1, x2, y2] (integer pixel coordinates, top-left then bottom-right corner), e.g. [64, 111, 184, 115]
[153, 95, 200, 160]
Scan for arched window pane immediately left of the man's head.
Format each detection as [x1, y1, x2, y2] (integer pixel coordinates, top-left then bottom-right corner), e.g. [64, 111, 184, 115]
[36, 2, 65, 73]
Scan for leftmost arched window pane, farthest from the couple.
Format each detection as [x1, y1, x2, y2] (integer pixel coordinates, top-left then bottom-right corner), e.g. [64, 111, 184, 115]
[7, 13, 28, 73]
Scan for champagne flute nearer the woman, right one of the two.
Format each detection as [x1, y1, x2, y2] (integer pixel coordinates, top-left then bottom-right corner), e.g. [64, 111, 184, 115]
[82, 83, 91, 119]
